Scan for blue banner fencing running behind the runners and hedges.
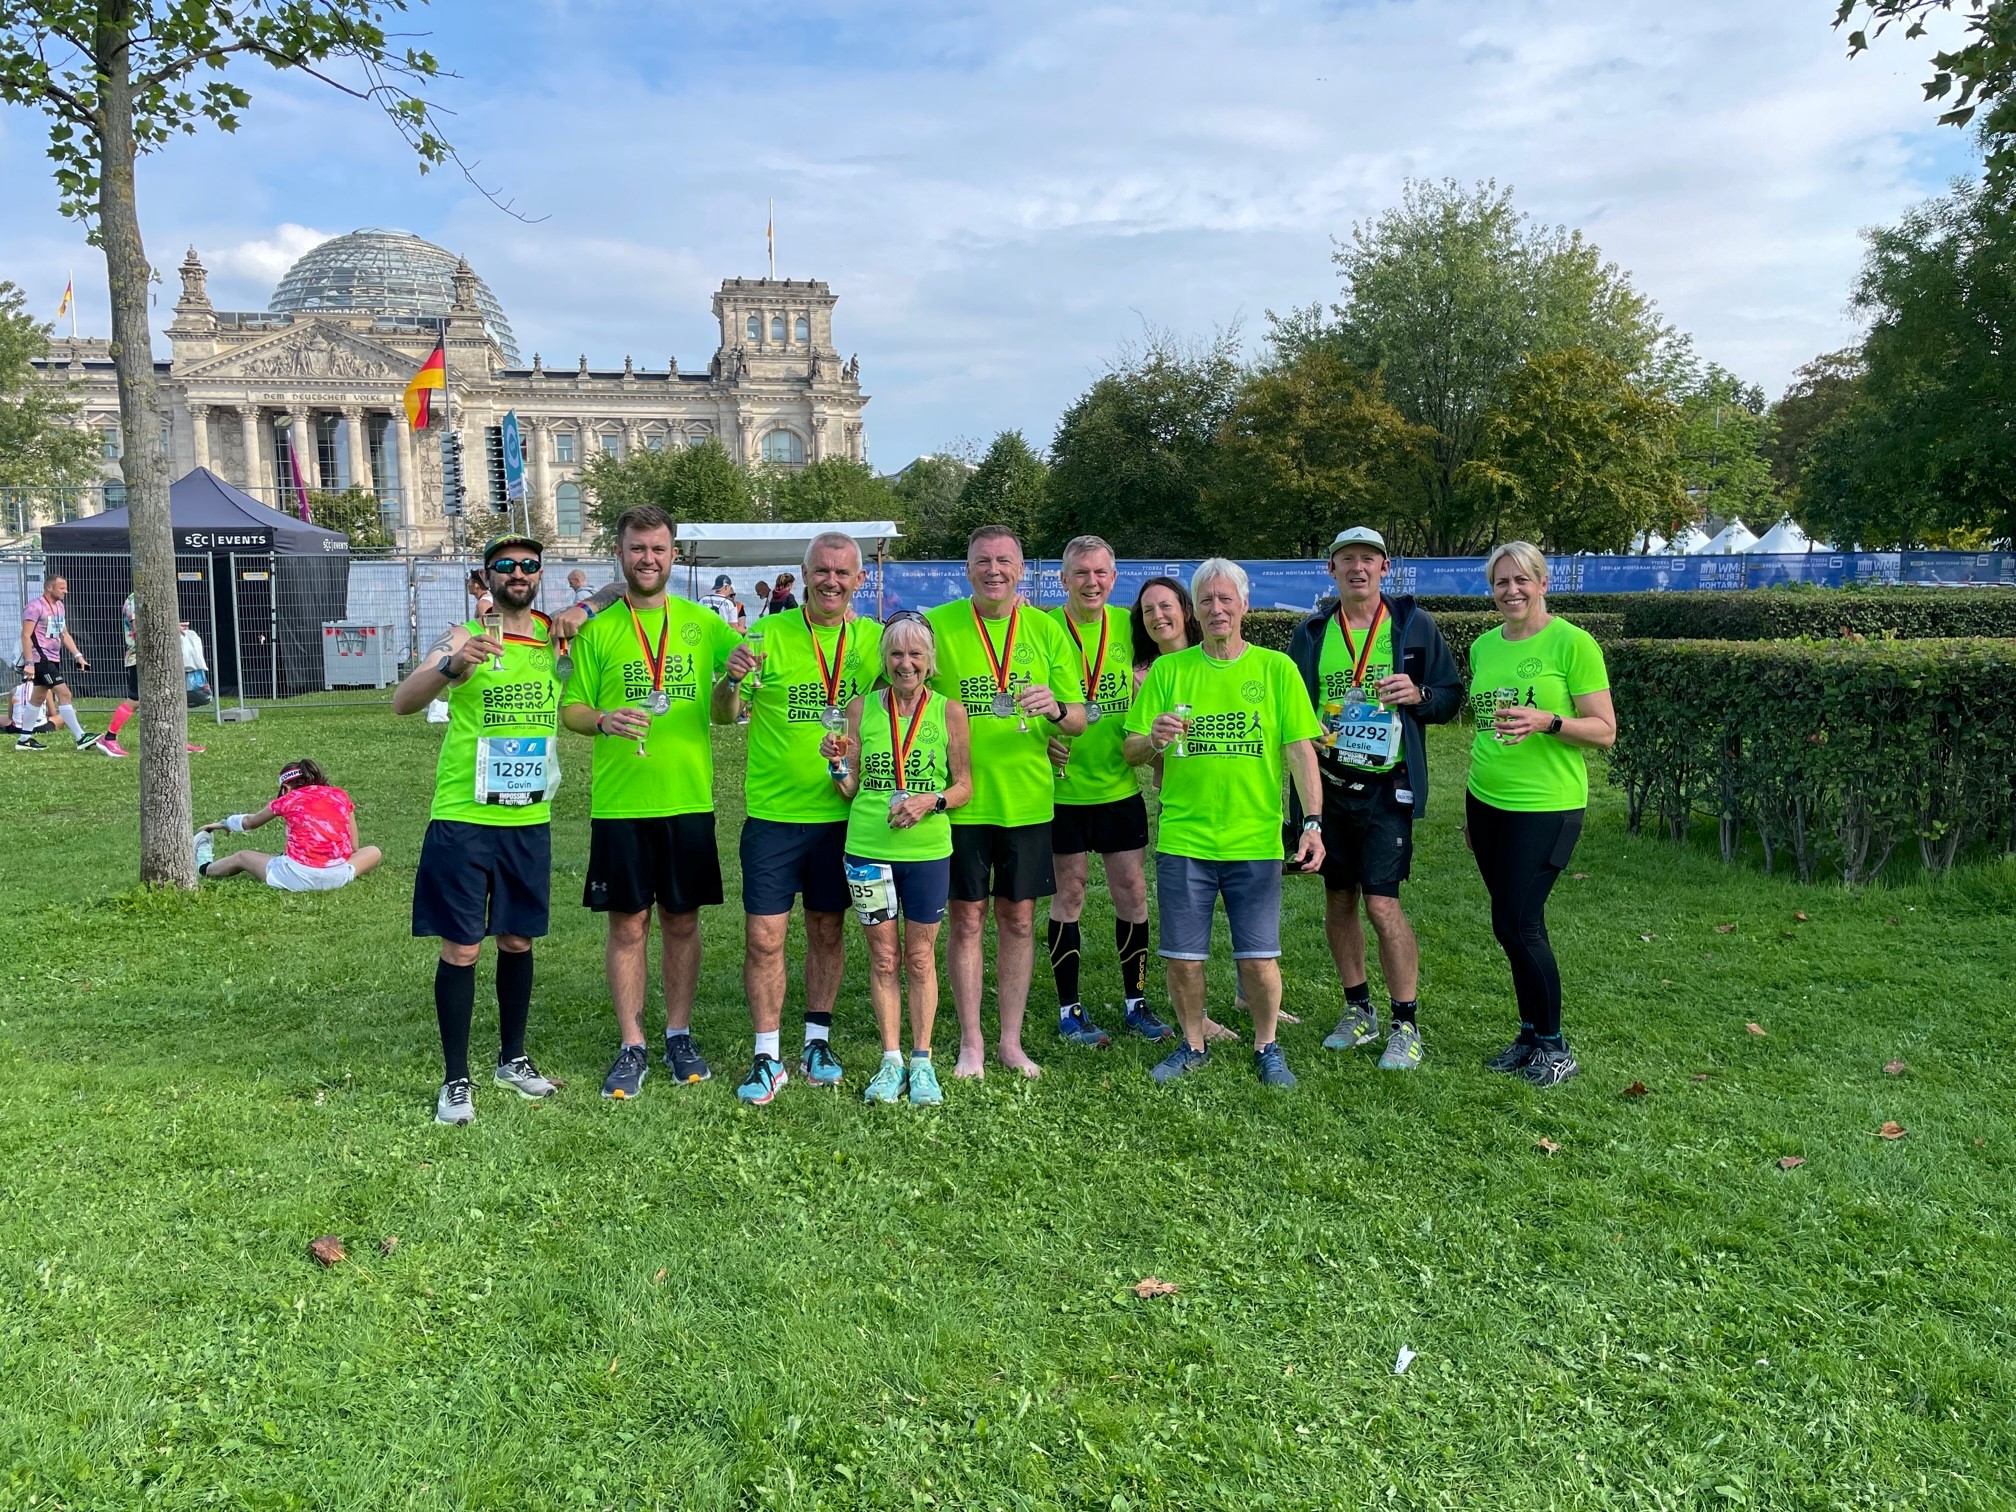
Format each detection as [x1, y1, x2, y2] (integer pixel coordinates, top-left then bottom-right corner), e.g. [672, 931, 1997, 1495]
[855, 550, 2016, 617]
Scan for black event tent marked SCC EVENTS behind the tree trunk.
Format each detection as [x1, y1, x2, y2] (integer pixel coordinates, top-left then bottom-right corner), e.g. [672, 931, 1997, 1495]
[42, 468, 351, 698]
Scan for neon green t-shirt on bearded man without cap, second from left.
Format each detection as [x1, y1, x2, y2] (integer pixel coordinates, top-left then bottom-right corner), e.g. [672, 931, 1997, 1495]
[560, 599, 742, 818]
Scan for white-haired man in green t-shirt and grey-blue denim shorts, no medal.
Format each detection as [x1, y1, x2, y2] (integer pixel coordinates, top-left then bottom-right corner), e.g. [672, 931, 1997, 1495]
[1121, 556, 1322, 1087]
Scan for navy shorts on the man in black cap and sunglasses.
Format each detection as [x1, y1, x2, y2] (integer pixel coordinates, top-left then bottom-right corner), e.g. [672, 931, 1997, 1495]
[413, 818, 552, 946]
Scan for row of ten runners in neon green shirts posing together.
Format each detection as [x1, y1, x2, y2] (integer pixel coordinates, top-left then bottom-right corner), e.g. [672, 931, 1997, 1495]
[393, 506, 1615, 1123]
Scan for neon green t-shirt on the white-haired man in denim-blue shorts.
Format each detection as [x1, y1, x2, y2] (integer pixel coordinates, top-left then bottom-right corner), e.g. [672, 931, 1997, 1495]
[1127, 645, 1322, 861]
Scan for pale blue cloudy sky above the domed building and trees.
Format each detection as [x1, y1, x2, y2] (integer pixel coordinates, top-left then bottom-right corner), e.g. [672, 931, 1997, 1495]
[0, 0, 1972, 470]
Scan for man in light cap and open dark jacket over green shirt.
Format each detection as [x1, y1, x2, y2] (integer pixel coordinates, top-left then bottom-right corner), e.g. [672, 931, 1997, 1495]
[1288, 526, 1464, 1070]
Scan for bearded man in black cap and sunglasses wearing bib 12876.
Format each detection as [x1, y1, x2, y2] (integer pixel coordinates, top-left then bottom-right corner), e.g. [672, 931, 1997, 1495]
[391, 534, 560, 1123]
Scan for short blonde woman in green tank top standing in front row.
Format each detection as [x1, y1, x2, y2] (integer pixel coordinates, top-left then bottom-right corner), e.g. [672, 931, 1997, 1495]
[821, 611, 974, 1103]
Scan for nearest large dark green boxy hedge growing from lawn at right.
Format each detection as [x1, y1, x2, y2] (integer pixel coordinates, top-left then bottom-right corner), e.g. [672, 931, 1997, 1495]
[1607, 641, 2016, 885]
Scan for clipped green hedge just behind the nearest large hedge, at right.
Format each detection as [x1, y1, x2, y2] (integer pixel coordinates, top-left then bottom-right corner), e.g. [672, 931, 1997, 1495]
[1620, 589, 2016, 641]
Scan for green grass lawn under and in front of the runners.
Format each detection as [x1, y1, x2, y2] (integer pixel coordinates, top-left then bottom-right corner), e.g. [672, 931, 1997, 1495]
[0, 712, 2016, 1508]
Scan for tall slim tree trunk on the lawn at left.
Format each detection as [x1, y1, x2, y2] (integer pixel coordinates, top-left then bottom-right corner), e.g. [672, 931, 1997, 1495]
[93, 0, 196, 887]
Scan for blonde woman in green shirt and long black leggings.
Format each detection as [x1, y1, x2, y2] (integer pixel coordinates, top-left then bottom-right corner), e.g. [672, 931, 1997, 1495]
[1464, 540, 1617, 1087]
